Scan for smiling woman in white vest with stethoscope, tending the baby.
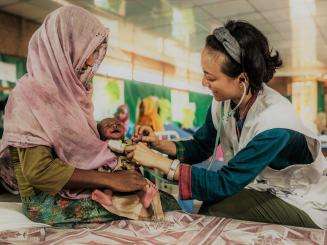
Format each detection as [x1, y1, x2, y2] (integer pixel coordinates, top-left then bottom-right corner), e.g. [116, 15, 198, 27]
[127, 21, 327, 229]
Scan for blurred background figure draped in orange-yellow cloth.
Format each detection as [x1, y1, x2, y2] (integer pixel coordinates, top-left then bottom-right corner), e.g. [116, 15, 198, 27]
[137, 96, 164, 132]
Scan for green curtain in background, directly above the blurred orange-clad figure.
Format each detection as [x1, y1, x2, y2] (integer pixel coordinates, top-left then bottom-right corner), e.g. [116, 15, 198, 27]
[124, 80, 171, 123]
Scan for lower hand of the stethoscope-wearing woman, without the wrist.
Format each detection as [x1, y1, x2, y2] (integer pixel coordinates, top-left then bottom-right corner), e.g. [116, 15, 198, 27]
[125, 142, 162, 168]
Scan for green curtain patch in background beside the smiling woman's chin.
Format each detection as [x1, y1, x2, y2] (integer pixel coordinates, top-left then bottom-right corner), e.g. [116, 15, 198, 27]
[189, 92, 212, 127]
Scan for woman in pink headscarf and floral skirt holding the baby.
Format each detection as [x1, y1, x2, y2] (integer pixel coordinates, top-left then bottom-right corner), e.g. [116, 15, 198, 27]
[1, 6, 178, 227]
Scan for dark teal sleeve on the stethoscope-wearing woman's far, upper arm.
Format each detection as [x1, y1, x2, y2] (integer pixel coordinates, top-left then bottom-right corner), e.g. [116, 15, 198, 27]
[175, 107, 217, 164]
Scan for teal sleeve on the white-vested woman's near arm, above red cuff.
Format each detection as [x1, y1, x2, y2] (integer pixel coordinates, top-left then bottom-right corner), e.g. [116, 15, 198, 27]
[191, 129, 312, 202]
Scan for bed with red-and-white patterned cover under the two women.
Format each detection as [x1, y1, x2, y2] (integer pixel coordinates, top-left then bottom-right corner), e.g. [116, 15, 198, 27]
[0, 202, 327, 245]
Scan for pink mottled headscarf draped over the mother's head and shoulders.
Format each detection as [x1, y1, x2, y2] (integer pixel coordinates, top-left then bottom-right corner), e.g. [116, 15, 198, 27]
[0, 6, 116, 169]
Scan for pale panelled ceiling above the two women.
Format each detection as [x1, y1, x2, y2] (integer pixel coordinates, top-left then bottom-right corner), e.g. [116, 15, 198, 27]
[0, 0, 327, 73]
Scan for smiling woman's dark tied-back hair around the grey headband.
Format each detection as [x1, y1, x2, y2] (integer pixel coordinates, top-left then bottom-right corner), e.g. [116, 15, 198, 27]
[206, 20, 282, 93]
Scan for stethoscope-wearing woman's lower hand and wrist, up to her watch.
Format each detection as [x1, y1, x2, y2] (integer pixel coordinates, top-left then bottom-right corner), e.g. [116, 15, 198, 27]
[125, 143, 172, 174]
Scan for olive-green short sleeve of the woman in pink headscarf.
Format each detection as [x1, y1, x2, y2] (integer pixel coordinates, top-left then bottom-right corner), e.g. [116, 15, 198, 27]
[18, 146, 75, 195]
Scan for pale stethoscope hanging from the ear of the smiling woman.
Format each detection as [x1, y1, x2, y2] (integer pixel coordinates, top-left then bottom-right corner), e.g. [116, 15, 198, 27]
[208, 81, 247, 170]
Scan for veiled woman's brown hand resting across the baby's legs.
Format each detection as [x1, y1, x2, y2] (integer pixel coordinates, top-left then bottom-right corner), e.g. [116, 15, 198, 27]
[109, 171, 148, 192]
